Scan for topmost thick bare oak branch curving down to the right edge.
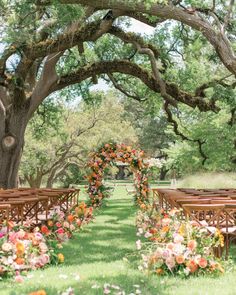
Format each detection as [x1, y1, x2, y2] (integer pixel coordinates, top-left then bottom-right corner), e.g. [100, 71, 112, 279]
[50, 0, 236, 74]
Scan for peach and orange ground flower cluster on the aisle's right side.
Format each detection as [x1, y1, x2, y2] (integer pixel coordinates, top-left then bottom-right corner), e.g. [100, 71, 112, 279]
[136, 208, 224, 276]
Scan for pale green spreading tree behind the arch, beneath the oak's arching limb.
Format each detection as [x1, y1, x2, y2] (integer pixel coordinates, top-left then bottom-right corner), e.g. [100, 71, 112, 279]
[20, 93, 137, 187]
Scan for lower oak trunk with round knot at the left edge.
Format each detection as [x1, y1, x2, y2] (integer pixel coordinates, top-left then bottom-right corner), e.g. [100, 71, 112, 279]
[0, 109, 27, 189]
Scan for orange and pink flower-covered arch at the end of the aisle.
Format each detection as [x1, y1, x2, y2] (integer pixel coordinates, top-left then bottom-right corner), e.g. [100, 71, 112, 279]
[87, 143, 149, 207]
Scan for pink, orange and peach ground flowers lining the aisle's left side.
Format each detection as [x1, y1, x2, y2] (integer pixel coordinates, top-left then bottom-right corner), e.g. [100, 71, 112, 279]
[0, 202, 93, 282]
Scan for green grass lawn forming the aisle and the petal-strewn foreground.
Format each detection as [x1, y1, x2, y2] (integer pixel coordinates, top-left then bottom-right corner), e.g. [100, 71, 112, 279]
[0, 187, 236, 295]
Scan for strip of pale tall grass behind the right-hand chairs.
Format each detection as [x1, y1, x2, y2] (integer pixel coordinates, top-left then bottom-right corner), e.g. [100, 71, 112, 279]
[178, 173, 236, 189]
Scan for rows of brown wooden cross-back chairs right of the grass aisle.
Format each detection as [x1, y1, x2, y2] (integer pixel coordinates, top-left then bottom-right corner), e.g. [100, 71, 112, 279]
[152, 188, 236, 257]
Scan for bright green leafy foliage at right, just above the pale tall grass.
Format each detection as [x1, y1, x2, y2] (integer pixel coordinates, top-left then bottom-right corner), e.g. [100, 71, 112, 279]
[164, 109, 236, 175]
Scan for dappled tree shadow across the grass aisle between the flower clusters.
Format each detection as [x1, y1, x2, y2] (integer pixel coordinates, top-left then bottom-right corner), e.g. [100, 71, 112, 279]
[63, 200, 137, 265]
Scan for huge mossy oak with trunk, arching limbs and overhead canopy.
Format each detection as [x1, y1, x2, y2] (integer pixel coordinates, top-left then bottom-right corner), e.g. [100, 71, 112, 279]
[0, 0, 236, 187]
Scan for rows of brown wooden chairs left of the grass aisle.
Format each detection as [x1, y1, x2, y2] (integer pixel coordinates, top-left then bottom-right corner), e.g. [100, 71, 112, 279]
[0, 188, 79, 227]
